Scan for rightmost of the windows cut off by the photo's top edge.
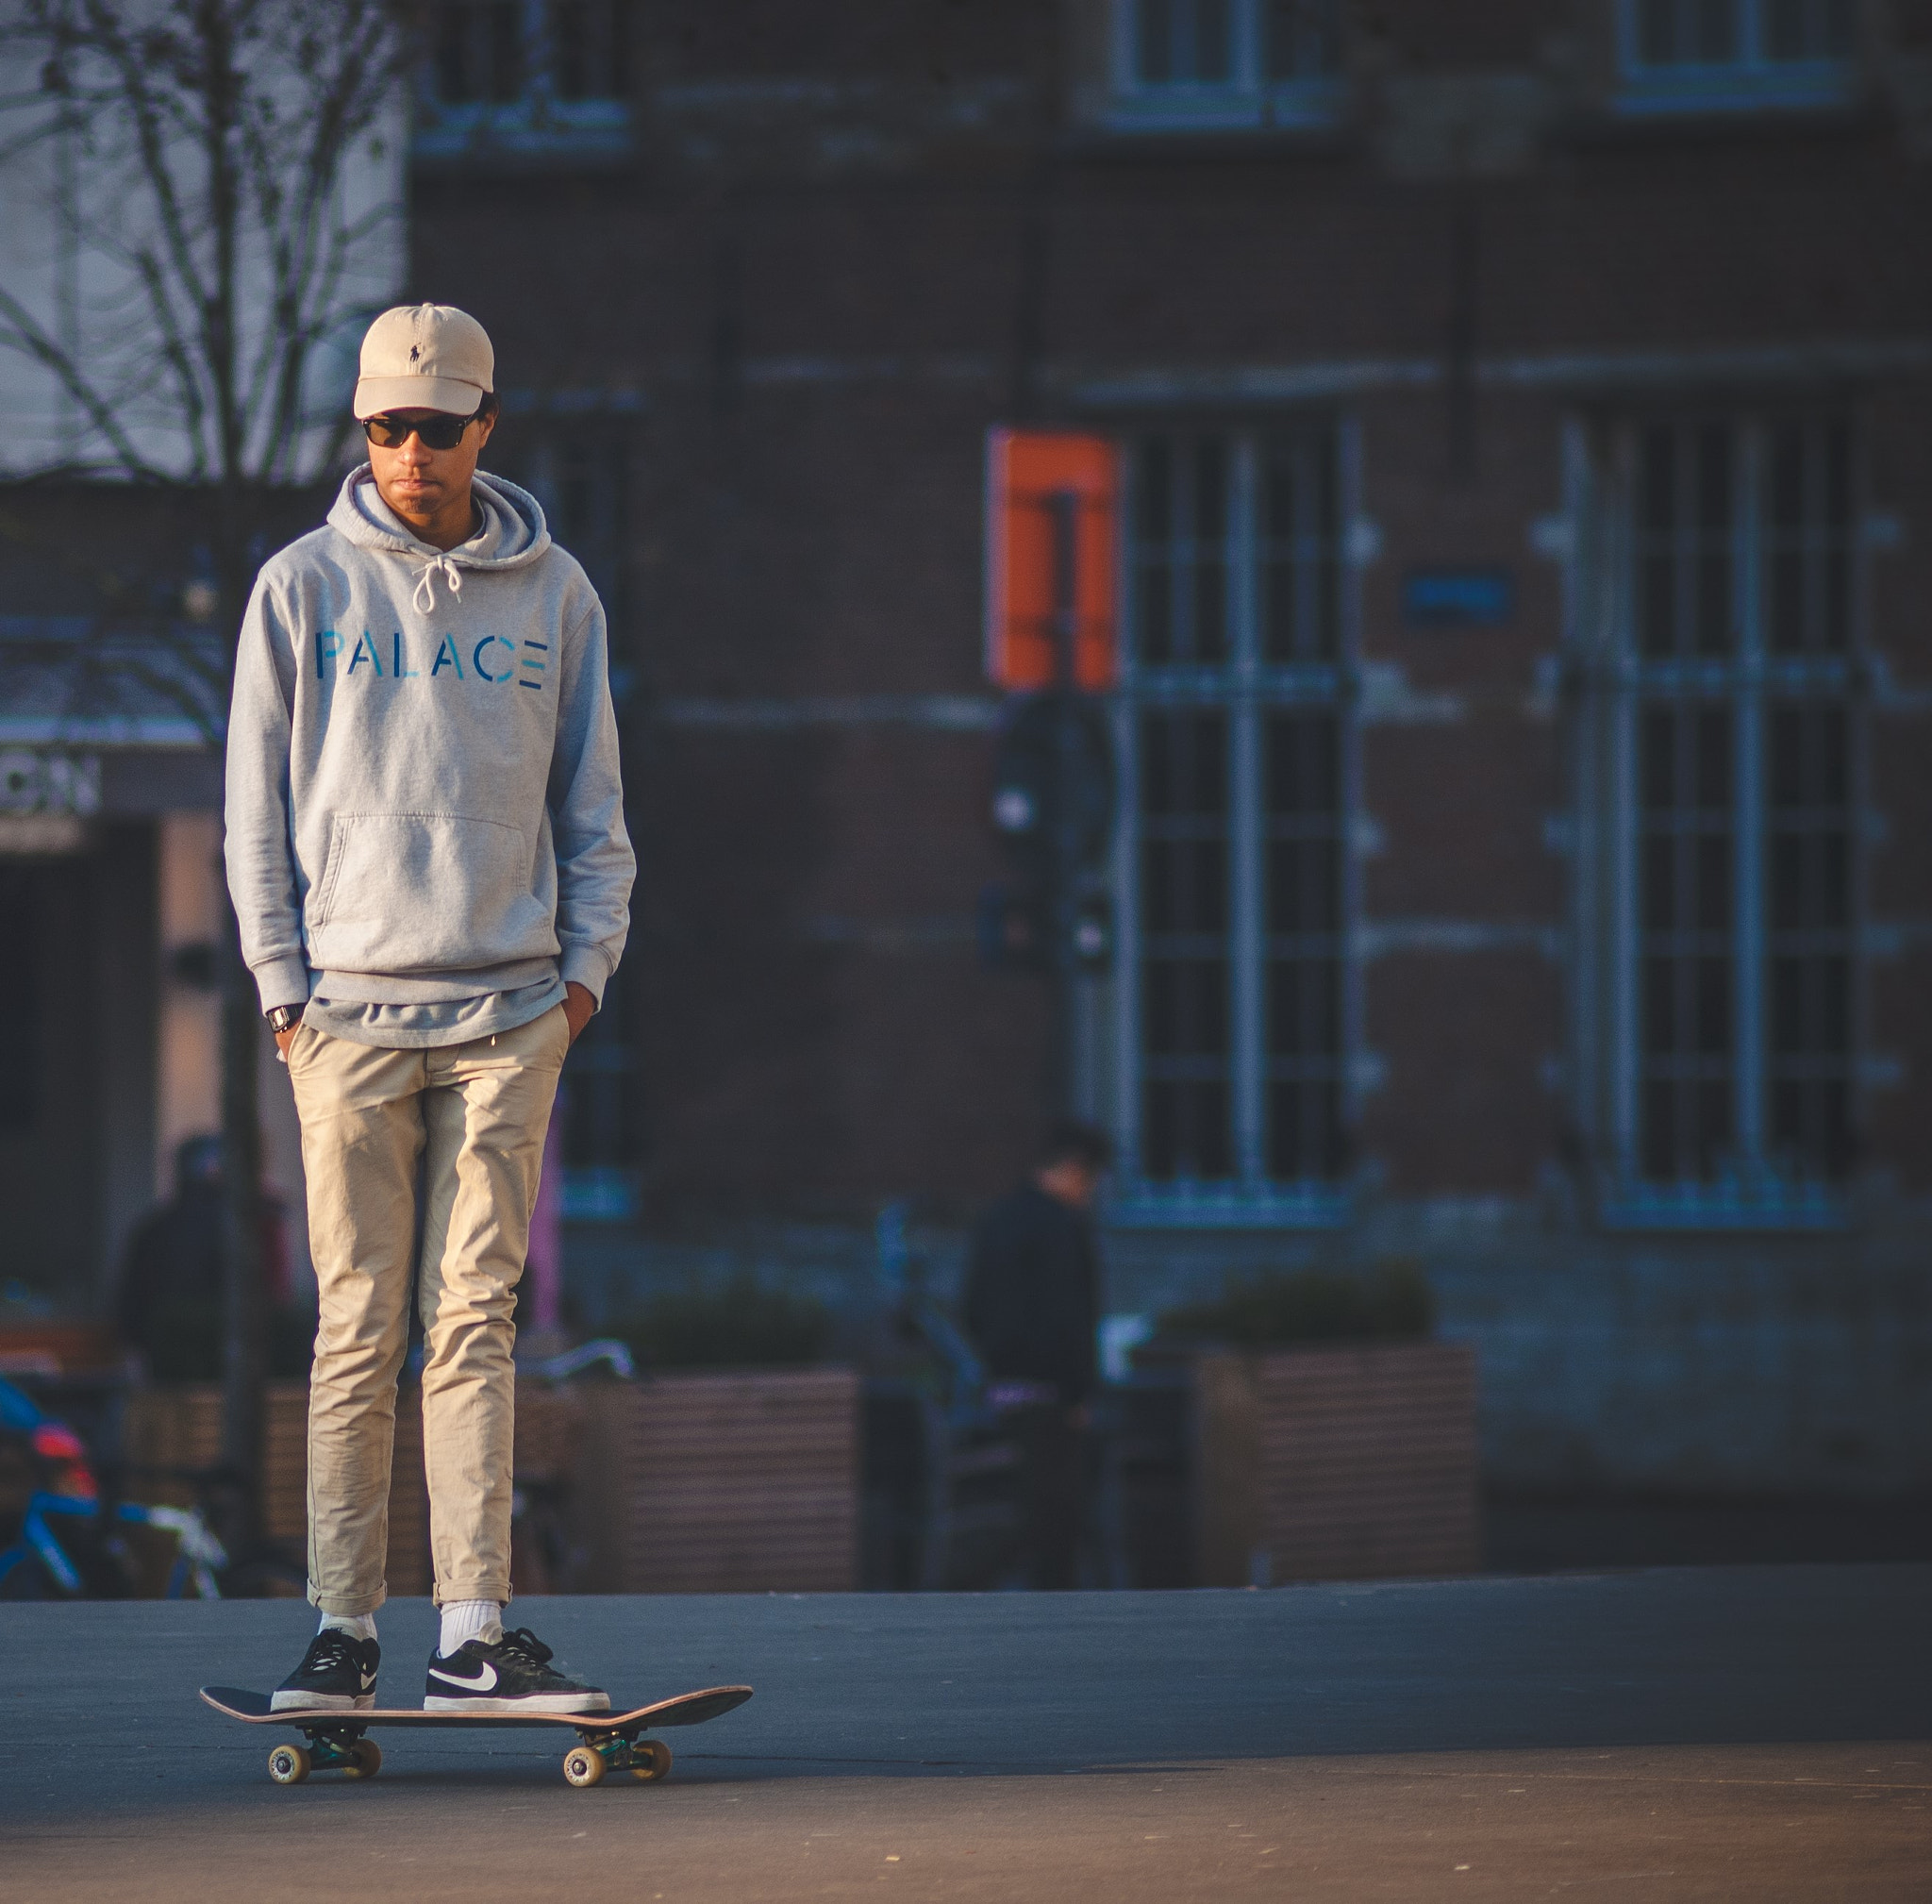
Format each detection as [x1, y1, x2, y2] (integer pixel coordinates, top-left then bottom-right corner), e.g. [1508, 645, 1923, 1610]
[1619, 0, 1855, 112]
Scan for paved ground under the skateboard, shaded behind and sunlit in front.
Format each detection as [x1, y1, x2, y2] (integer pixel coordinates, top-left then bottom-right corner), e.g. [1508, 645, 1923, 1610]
[0, 1565, 1932, 1904]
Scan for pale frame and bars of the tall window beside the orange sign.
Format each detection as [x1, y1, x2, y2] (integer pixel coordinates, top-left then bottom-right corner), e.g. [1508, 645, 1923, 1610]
[1108, 420, 1362, 1229]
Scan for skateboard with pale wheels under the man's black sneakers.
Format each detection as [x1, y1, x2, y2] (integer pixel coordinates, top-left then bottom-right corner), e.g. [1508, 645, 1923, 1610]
[201, 1685, 752, 1790]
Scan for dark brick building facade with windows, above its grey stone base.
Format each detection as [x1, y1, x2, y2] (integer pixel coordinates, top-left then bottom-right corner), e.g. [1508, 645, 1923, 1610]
[413, 0, 1932, 1233]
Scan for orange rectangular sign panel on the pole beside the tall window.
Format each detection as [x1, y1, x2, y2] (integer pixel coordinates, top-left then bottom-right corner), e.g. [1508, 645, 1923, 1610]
[985, 429, 1121, 693]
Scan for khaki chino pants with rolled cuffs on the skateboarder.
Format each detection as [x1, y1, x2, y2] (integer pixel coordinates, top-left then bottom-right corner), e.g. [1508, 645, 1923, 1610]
[288, 1005, 570, 1616]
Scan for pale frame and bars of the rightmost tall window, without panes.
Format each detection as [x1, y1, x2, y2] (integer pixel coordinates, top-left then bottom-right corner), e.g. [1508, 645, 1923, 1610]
[1565, 406, 1866, 1231]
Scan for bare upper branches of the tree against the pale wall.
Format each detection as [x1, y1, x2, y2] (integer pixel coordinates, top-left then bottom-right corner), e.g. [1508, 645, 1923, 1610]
[0, 0, 408, 491]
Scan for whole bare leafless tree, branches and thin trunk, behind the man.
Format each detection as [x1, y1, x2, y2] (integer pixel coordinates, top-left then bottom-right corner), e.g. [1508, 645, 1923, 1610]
[0, 0, 409, 1539]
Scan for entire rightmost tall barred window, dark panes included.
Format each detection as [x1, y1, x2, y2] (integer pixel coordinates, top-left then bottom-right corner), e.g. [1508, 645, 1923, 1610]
[1586, 413, 1858, 1224]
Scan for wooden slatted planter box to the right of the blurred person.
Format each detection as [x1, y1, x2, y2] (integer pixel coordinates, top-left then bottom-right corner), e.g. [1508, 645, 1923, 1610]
[1194, 1342, 1480, 1587]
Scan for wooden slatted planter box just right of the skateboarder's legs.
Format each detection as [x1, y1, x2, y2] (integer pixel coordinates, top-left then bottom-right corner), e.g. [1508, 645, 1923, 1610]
[572, 1369, 859, 1593]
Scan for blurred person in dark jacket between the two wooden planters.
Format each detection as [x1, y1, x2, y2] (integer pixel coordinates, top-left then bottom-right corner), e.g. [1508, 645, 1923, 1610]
[964, 1119, 1113, 1589]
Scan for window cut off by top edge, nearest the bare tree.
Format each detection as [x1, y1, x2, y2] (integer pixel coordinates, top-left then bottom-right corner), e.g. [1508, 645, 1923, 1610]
[415, 0, 632, 159]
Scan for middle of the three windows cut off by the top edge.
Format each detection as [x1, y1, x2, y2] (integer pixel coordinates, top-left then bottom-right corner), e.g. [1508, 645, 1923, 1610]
[1113, 0, 1341, 127]
